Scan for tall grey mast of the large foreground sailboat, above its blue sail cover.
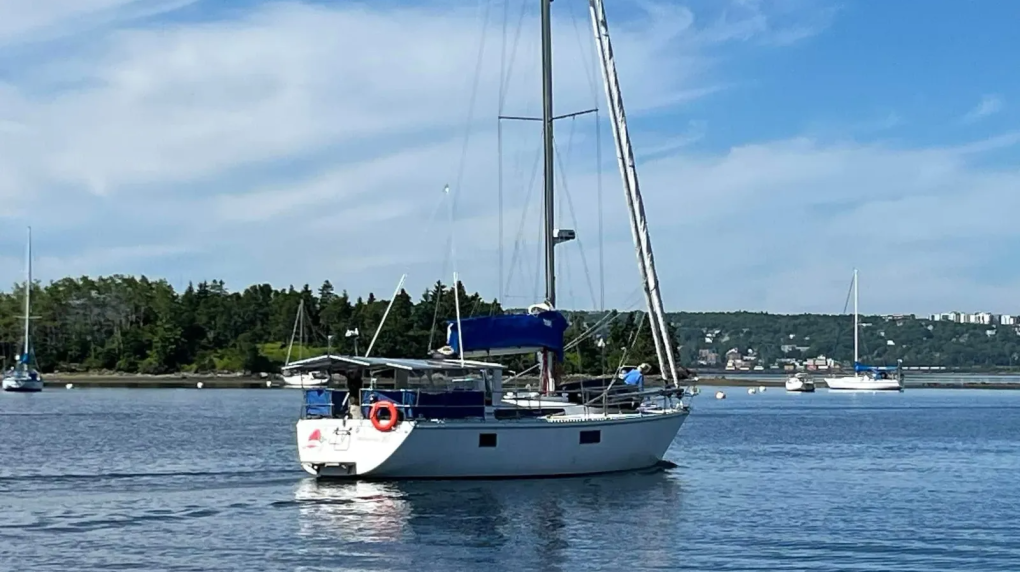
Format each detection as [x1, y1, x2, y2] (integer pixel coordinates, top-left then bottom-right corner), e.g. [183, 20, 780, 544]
[542, 0, 556, 308]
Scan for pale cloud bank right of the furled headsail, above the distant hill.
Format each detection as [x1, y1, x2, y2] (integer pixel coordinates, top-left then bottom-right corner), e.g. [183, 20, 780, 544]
[643, 133, 1020, 313]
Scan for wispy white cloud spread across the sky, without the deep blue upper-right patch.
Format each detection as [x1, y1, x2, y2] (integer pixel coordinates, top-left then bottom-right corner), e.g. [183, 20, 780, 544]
[0, 0, 1017, 311]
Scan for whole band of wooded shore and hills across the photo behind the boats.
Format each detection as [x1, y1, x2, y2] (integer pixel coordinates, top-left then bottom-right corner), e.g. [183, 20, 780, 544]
[0, 275, 1020, 374]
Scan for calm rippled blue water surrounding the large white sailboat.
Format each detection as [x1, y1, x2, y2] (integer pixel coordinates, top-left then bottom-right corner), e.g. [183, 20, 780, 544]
[0, 387, 1020, 572]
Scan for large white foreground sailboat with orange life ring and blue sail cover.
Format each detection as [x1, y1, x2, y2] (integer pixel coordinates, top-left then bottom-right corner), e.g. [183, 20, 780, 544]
[289, 0, 691, 478]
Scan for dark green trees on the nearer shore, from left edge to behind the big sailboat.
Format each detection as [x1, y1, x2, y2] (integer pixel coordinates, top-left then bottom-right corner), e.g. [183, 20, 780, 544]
[0, 275, 651, 374]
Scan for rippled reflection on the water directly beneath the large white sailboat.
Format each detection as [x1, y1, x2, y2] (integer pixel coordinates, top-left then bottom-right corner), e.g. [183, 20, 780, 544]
[295, 468, 682, 572]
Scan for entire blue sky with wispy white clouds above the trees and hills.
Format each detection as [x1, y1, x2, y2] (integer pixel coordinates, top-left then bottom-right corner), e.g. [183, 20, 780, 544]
[0, 0, 1020, 313]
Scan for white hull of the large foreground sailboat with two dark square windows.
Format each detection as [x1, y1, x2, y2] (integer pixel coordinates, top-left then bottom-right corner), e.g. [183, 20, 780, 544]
[297, 409, 687, 478]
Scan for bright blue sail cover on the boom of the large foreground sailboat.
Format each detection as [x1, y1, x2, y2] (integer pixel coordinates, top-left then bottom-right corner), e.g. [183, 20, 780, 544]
[447, 310, 567, 360]
